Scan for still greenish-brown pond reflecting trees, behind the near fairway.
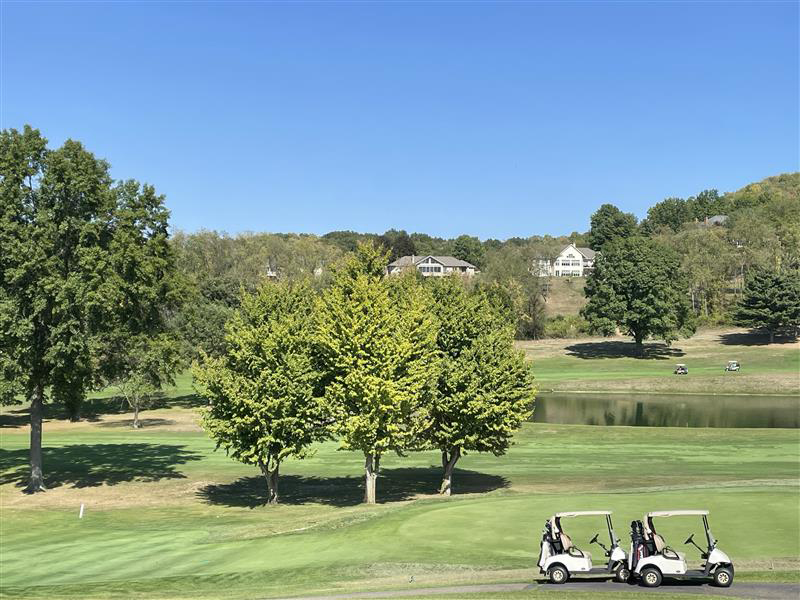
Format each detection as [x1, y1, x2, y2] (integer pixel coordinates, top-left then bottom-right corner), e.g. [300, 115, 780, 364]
[532, 393, 800, 428]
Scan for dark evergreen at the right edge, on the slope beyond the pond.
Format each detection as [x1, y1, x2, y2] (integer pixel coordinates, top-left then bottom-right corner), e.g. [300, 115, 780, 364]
[733, 269, 800, 343]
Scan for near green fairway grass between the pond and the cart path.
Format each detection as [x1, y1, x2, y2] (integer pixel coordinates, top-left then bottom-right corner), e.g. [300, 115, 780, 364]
[0, 381, 800, 599]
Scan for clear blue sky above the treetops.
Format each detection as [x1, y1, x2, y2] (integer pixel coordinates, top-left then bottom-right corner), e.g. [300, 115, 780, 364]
[0, 1, 800, 238]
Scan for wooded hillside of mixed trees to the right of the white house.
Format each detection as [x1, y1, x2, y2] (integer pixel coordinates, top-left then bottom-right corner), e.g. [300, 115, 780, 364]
[581, 173, 800, 348]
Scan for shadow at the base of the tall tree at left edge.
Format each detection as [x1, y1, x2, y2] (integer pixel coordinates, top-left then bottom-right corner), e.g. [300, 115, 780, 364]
[0, 444, 202, 488]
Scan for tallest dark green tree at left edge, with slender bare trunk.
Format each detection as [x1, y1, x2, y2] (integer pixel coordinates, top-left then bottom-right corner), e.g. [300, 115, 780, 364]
[0, 126, 174, 492]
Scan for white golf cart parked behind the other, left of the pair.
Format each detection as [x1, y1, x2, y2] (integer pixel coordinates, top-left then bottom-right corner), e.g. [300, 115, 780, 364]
[538, 510, 630, 583]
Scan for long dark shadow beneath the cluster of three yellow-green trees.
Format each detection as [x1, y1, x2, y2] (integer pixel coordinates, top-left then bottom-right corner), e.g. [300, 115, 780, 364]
[197, 466, 510, 508]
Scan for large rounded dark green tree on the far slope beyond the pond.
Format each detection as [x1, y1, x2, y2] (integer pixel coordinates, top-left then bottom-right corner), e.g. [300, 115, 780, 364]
[581, 237, 694, 351]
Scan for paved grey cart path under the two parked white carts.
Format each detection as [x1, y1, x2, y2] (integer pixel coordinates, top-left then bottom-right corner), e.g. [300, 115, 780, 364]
[286, 580, 800, 600]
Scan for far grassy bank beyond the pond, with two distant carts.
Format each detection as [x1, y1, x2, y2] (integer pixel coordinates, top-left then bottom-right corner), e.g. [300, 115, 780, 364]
[519, 329, 800, 395]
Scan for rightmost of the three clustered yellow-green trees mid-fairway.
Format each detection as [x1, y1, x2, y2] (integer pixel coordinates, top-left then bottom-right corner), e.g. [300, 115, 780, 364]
[426, 277, 535, 496]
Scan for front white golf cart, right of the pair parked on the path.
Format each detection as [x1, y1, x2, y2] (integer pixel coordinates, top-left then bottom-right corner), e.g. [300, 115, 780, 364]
[628, 510, 733, 587]
